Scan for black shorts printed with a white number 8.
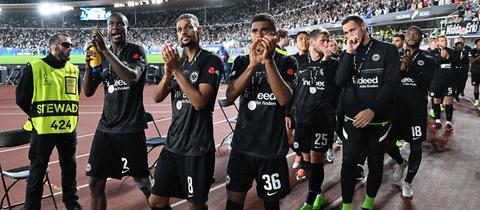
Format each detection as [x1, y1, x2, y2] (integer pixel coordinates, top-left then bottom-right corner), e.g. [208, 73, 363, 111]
[152, 149, 215, 204]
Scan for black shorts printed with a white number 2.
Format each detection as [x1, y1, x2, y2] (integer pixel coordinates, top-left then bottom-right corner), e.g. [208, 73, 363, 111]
[86, 130, 150, 179]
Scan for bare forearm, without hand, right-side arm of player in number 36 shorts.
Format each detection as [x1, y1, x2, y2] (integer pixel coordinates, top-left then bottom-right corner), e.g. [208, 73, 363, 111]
[265, 59, 292, 106]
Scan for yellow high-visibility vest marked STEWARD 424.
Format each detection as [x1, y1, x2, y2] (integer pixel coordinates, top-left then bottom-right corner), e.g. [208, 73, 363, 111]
[30, 60, 79, 134]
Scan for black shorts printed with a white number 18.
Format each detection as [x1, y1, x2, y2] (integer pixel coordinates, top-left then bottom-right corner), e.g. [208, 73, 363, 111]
[388, 109, 427, 142]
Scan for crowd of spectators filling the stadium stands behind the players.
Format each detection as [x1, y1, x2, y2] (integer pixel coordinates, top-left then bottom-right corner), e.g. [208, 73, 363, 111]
[0, 0, 479, 52]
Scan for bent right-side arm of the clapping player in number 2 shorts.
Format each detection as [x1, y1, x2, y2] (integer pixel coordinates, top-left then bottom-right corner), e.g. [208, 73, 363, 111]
[93, 30, 145, 86]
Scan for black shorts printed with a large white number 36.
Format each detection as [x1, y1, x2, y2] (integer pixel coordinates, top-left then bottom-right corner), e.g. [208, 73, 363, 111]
[226, 150, 290, 201]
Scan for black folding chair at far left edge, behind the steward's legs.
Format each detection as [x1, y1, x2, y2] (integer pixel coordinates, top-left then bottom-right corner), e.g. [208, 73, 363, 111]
[0, 130, 58, 209]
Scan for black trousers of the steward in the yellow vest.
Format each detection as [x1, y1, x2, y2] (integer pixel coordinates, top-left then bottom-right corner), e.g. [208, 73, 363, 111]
[25, 131, 78, 210]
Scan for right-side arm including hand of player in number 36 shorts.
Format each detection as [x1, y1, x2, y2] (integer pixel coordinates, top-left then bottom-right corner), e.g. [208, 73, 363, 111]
[262, 36, 298, 106]
